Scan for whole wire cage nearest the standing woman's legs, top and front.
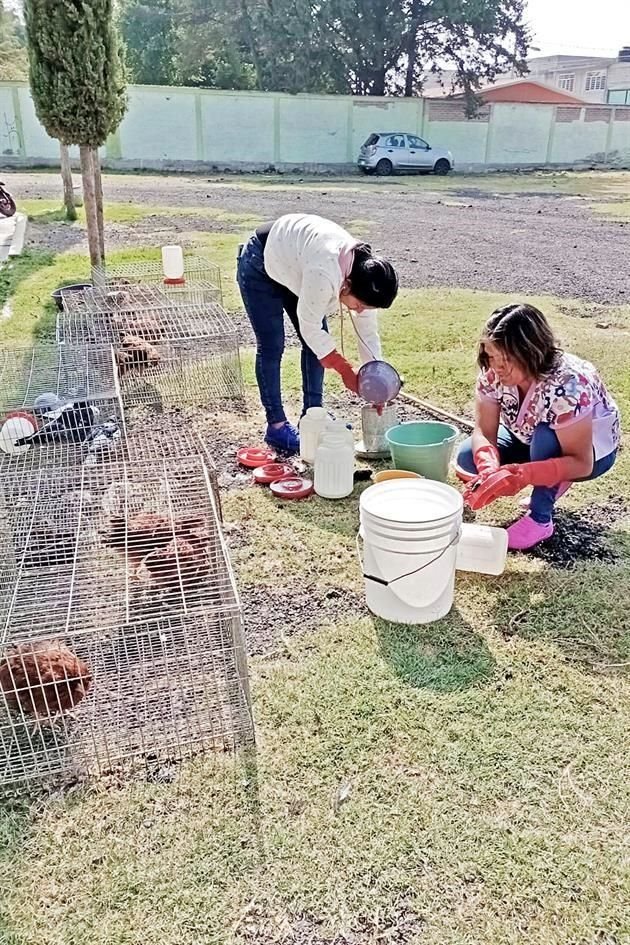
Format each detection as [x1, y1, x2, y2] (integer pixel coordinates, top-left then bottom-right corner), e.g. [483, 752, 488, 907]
[57, 285, 244, 409]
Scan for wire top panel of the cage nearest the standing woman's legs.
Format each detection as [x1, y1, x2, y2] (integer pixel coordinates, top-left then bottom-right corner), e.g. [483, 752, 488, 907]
[57, 285, 237, 345]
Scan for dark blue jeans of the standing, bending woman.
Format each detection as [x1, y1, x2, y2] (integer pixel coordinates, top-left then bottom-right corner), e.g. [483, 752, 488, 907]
[236, 236, 328, 423]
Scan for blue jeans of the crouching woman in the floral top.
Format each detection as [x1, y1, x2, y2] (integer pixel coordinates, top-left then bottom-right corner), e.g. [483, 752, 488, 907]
[457, 423, 617, 525]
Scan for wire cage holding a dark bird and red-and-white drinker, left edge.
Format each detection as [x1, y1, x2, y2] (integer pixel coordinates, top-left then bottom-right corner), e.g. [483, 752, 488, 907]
[0, 344, 123, 476]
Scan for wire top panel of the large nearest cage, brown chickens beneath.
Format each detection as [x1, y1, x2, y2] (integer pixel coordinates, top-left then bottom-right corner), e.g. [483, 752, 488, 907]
[0, 455, 234, 641]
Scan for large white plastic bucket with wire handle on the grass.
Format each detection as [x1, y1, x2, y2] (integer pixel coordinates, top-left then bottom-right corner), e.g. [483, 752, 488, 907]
[359, 479, 463, 624]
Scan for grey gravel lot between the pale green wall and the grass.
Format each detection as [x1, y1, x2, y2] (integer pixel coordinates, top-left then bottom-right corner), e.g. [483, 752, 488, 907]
[5, 173, 630, 304]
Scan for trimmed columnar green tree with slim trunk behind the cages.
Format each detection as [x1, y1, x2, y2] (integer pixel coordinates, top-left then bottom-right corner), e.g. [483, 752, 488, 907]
[24, 0, 127, 266]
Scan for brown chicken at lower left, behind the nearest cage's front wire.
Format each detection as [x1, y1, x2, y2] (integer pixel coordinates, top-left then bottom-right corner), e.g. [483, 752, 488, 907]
[0, 641, 92, 718]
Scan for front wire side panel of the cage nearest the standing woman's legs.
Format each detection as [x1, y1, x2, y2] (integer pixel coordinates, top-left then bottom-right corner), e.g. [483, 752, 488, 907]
[115, 335, 245, 410]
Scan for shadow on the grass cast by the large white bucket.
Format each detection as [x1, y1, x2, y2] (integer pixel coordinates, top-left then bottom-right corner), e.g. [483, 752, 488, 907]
[372, 610, 495, 692]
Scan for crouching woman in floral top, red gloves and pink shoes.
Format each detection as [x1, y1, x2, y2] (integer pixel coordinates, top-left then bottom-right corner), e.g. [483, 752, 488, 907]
[457, 305, 620, 551]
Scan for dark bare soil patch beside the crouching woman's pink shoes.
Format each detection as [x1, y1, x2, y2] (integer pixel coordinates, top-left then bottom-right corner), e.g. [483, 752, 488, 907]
[528, 495, 630, 568]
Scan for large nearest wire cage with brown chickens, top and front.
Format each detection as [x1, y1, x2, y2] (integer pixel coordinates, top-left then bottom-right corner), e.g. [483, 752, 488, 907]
[0, 457, 252, 782]
